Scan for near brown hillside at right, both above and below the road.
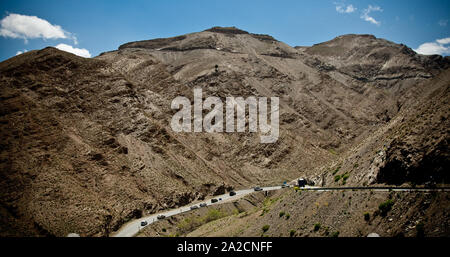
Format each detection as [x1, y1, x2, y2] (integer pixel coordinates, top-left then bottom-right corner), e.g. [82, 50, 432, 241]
[144, 67, 450, 237]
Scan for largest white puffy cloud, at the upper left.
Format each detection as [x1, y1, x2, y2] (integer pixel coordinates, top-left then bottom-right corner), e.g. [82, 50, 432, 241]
[0, 13, 76, 44]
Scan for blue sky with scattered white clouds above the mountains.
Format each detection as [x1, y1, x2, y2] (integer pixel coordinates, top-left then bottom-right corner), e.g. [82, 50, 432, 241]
[0, 0, 450, 60]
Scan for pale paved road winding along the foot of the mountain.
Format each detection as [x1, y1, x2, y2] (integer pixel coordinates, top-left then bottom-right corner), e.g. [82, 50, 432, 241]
[111, 186, 450, 237]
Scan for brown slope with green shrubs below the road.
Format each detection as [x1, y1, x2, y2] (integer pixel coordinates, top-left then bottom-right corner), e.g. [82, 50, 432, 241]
[138, 189, 450, 237]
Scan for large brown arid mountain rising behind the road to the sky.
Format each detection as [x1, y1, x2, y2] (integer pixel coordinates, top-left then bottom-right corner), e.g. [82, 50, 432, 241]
[0, 27, 450, 236]
